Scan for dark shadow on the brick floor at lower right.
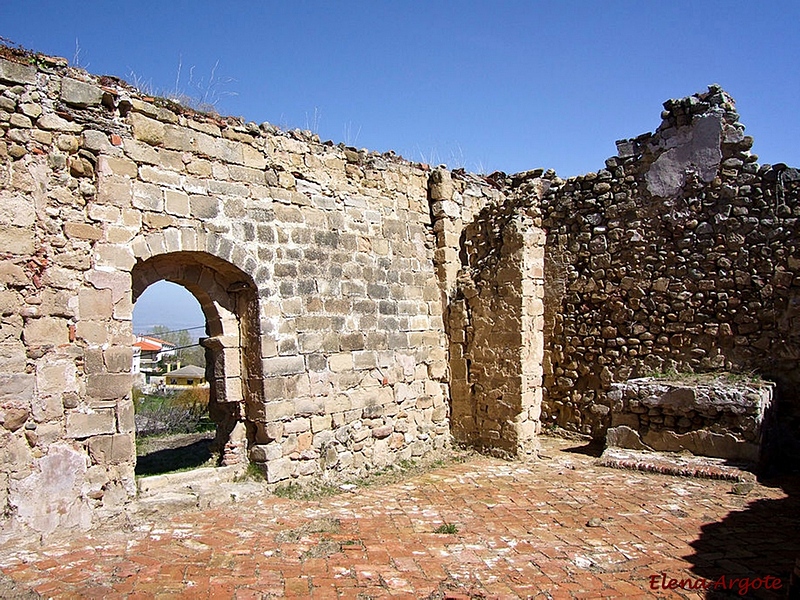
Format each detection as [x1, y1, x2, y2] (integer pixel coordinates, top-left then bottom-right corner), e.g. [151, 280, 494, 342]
[686, 472, 800, 599]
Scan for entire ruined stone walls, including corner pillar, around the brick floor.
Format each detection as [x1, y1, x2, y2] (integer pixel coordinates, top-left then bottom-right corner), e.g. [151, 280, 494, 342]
[0, 43, 800, 535]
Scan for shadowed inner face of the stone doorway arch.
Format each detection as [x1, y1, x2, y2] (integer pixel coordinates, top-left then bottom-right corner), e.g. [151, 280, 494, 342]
[131, 251, 263, 465]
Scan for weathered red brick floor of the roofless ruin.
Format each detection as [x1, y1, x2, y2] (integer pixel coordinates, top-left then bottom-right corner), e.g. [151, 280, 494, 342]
[0, 440, 800, 600]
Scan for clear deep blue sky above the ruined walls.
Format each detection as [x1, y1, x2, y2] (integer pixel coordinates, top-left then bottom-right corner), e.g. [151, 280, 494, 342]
[0, 0, 800, 330]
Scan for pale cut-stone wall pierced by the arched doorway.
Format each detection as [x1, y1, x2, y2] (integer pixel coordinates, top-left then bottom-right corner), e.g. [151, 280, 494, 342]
[0, 51, 450, 535]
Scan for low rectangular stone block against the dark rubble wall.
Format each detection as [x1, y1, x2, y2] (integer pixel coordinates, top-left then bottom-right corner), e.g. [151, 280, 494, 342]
[606, 377, 774, 463]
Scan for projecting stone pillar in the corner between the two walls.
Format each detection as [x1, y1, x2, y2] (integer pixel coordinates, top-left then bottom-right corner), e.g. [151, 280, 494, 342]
[431, 170, 544, 456]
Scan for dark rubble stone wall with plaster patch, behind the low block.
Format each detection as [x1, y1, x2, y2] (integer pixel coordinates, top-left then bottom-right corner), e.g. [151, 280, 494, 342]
[542, 86, 800, 448]
